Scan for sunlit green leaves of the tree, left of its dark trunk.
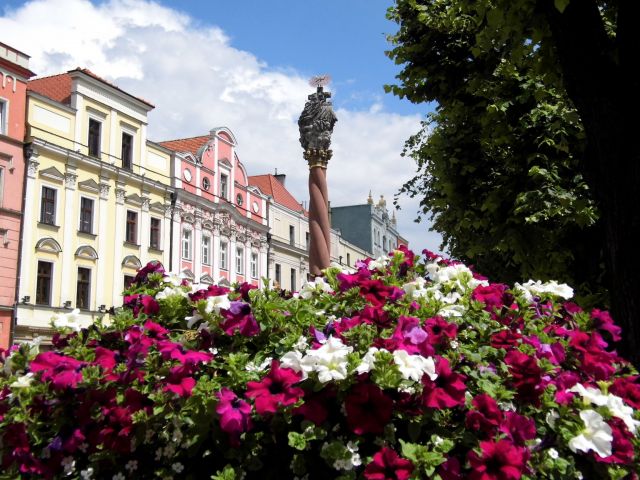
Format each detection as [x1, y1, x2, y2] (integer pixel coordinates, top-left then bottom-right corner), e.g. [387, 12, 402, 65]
[386, 0, 611, 301]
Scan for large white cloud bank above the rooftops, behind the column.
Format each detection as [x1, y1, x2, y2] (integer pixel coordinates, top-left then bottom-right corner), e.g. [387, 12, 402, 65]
[0, 0, 439, 250]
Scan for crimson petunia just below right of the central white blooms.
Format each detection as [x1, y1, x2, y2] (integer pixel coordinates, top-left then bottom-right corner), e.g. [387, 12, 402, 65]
[422, 357, 467, 408]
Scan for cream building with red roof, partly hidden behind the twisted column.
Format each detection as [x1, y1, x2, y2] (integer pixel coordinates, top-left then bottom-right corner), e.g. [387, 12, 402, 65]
[249, 174, 369, 291]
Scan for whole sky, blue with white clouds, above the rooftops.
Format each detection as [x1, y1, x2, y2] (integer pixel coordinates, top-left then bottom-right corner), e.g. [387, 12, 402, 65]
[0, 0, 440, 251]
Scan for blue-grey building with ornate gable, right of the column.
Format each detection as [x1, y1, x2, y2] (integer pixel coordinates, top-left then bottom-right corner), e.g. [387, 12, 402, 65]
[331, 193, 406, 258]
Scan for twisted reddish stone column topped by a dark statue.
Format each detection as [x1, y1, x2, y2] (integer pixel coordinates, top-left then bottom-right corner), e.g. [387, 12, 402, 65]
[298, 75, 338, 276]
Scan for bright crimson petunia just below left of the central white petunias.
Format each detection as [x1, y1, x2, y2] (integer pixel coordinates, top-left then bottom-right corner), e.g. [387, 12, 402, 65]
[245, 360, 304, 415]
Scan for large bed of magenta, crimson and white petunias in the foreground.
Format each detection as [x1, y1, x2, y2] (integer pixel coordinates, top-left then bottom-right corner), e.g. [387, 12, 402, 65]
[0, 249, 640, 480]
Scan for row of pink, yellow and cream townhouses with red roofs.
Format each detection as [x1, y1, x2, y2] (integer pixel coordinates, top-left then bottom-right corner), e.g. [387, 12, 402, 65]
[0, 44, 408, 348]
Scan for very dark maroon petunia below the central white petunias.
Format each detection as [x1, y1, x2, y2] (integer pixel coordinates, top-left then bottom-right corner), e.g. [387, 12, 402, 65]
[344, 382, 392, 435]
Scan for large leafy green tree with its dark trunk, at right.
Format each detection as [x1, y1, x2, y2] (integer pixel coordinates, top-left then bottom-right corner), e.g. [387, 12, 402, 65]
[388, 0, 640, 364]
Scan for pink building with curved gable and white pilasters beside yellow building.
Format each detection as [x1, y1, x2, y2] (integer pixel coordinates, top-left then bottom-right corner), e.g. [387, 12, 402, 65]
[160, 127, 269, 285]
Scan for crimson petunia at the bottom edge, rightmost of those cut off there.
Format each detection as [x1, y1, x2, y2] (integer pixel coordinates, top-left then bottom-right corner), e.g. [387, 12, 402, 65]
[467, 440, 529, 480]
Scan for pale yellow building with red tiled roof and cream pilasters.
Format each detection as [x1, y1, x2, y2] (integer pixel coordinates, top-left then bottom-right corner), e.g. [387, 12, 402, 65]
[14, 69, 173, 341]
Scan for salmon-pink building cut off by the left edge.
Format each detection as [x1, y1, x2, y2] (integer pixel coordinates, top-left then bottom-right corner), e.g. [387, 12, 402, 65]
[0, 43, 35, 348]
